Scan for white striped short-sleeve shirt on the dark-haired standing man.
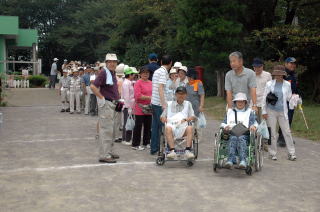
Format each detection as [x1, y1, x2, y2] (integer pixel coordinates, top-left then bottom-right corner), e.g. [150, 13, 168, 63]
[151, 66, 169, 106]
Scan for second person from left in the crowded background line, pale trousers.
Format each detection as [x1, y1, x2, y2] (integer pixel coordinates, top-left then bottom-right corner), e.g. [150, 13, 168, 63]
[70, 69, 81, 114]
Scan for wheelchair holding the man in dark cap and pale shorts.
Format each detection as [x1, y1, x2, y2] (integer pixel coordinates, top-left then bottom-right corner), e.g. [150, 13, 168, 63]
[156, 121, 199, 167]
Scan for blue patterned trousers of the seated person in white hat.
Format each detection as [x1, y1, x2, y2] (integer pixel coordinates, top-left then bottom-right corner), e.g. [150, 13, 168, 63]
[228, 135, 249, 162]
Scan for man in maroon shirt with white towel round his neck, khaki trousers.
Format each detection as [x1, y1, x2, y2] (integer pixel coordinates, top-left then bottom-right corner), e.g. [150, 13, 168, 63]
[90, 53, 120, 163]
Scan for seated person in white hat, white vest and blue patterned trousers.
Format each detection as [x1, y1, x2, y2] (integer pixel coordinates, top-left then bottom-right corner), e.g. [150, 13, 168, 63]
[221, 93, 258, 168]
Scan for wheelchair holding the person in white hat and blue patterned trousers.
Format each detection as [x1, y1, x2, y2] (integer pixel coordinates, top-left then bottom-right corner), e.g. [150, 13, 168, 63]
[213, 128, 264, 175]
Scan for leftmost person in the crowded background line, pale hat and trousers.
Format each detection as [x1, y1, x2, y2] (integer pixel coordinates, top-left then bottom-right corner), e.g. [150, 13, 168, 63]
[59, 69, 71, 112]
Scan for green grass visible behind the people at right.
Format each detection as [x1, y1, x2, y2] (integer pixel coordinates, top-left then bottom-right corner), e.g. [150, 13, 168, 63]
[205, 97, 320, 141]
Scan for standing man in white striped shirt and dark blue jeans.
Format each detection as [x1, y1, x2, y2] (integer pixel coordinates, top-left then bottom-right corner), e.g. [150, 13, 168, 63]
[150, 55, 172, 155]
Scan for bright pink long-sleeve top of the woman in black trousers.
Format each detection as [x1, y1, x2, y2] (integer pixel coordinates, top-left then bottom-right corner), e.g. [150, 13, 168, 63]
[134, 80, 152, 115]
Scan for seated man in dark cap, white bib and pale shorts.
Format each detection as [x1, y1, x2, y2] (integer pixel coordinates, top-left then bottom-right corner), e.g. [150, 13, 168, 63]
[160, 86, 196, 159]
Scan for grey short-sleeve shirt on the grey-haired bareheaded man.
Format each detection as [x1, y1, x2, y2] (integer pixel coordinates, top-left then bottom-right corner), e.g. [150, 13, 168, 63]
[225, 67, 257, 101]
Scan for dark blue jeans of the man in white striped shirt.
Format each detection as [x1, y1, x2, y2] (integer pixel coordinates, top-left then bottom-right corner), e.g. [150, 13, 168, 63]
[150, 105, 163, 154]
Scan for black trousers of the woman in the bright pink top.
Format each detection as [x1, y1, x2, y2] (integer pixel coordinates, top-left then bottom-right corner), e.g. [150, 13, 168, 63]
[132, 115, 152, 146]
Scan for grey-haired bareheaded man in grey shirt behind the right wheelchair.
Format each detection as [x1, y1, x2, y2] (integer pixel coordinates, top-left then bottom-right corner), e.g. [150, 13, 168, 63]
[225, 52, 258, 111]
